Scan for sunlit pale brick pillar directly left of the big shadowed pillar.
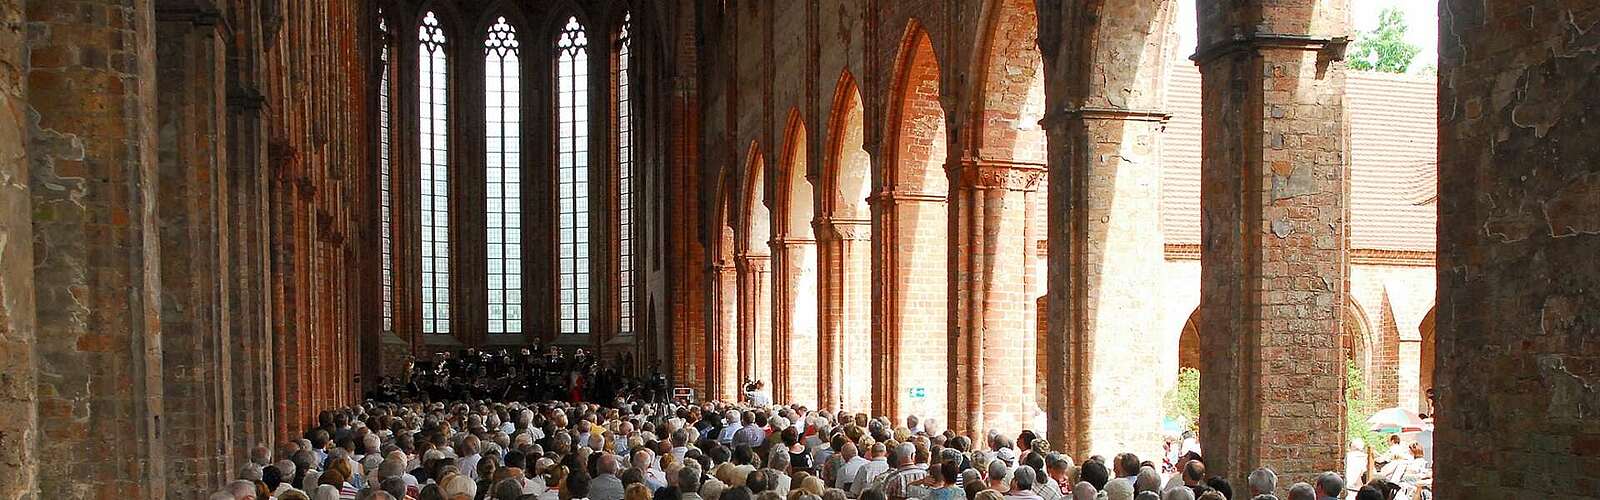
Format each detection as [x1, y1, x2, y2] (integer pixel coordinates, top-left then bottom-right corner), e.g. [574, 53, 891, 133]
[1043, 107, 1166, 457]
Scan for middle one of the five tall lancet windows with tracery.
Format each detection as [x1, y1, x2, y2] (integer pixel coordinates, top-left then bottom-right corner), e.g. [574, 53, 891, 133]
[483, 18, 522, 333]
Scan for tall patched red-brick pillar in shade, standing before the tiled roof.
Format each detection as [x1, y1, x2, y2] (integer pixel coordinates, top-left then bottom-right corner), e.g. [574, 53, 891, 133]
[1195, 0, 1350, 484]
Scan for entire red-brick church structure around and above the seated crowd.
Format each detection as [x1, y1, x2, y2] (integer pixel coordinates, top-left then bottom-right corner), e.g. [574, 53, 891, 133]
[0, 0, 1600, 498]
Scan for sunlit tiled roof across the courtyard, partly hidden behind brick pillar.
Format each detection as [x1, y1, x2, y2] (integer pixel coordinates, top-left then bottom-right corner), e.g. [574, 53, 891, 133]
[1162, 64, 1438, 252]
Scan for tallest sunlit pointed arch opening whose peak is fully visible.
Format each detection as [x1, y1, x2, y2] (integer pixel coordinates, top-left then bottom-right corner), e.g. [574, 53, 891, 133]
[872, 21, 950, 418]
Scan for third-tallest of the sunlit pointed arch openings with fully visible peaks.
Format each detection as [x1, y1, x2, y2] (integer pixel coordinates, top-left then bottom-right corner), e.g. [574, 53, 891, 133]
[773, 111, 818, 407]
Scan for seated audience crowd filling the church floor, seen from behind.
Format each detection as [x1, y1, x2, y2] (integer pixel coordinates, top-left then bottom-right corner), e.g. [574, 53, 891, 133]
[213, 375, 1422, 500]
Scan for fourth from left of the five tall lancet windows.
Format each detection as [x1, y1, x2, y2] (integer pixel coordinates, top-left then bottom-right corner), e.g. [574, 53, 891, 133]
[555, 18, 589, 335]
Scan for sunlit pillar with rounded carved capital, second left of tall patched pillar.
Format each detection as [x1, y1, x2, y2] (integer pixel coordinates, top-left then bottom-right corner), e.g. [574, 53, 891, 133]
[949, 159, 1045, 436]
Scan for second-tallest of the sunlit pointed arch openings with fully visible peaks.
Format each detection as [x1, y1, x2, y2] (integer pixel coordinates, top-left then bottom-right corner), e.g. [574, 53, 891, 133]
[814, 72, 872, 409]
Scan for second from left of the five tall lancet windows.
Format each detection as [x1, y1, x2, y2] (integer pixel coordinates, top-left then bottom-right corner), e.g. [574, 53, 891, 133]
[418, 11, 450, 335]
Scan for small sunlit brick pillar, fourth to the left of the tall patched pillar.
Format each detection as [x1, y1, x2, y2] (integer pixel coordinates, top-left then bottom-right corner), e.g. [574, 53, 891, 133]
[813, 218, 872, 412]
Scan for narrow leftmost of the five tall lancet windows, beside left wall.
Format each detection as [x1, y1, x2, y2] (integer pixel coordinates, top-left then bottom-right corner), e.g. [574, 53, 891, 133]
[378, 10, 395, 332]
